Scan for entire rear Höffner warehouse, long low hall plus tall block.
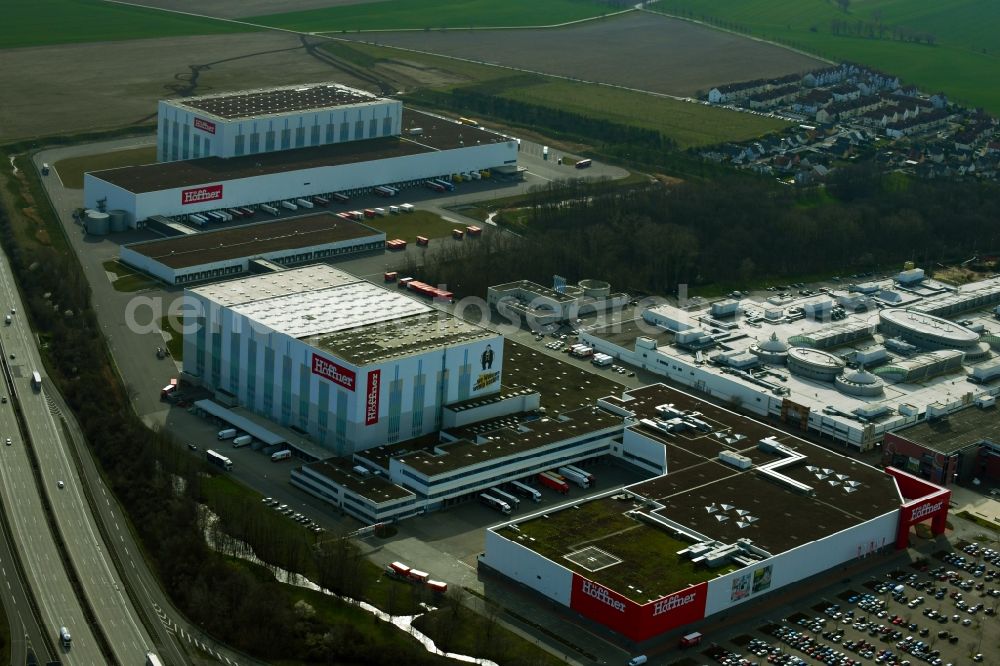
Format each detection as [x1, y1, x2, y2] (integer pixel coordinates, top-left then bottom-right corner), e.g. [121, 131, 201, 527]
[84, 84, 518, 227]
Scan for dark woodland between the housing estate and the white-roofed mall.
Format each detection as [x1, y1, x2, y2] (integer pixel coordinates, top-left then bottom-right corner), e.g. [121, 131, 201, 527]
[408, 164, 1000, 296]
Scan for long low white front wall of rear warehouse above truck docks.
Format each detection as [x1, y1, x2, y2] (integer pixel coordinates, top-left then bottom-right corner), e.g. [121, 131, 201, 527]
[84, 141, 517, 227]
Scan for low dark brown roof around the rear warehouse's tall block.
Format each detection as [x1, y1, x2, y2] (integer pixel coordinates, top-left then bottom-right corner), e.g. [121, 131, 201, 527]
[88, 109, 508, 194]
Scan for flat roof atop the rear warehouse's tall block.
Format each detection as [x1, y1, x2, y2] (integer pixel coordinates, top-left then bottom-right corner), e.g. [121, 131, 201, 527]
[168, 83, 386, 120]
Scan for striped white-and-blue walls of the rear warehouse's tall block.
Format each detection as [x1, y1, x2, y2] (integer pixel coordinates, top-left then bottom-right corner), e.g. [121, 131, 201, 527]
[156, 86, 403, 162]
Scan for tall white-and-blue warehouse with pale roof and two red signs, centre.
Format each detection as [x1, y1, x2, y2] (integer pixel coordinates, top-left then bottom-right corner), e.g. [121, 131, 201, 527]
[184, 264, 503, 455]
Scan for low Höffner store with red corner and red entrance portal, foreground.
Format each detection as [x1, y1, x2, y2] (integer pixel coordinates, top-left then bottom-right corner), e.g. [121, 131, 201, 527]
[480, 385, 951, 643]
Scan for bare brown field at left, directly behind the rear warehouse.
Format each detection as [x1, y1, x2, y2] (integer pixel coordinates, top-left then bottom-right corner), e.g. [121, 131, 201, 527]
[0, 33, 379, 141]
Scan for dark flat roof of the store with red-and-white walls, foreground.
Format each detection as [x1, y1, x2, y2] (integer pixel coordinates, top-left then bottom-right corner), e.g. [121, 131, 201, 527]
[501, 384, 900, 602]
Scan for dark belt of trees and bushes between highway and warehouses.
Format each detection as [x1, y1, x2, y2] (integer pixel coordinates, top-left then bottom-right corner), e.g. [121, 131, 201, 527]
[0, 162, 443, 664]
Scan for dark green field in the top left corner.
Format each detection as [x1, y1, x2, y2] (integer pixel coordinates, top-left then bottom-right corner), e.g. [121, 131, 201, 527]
[0, 0, 253, 50]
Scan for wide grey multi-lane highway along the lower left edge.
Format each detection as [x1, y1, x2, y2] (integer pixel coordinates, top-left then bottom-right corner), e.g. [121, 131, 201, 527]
[0, 250, 151, 664]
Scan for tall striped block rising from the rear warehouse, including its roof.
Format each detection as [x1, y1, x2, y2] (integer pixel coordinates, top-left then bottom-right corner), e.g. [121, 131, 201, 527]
[156, 83, 403, 162]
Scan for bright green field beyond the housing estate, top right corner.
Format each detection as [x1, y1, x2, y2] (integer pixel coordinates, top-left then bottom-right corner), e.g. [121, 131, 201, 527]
[651, 0, 1000, 113]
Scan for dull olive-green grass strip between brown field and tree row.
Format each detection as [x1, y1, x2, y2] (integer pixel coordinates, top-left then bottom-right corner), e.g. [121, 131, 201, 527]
[324, 42, 787, 148]
